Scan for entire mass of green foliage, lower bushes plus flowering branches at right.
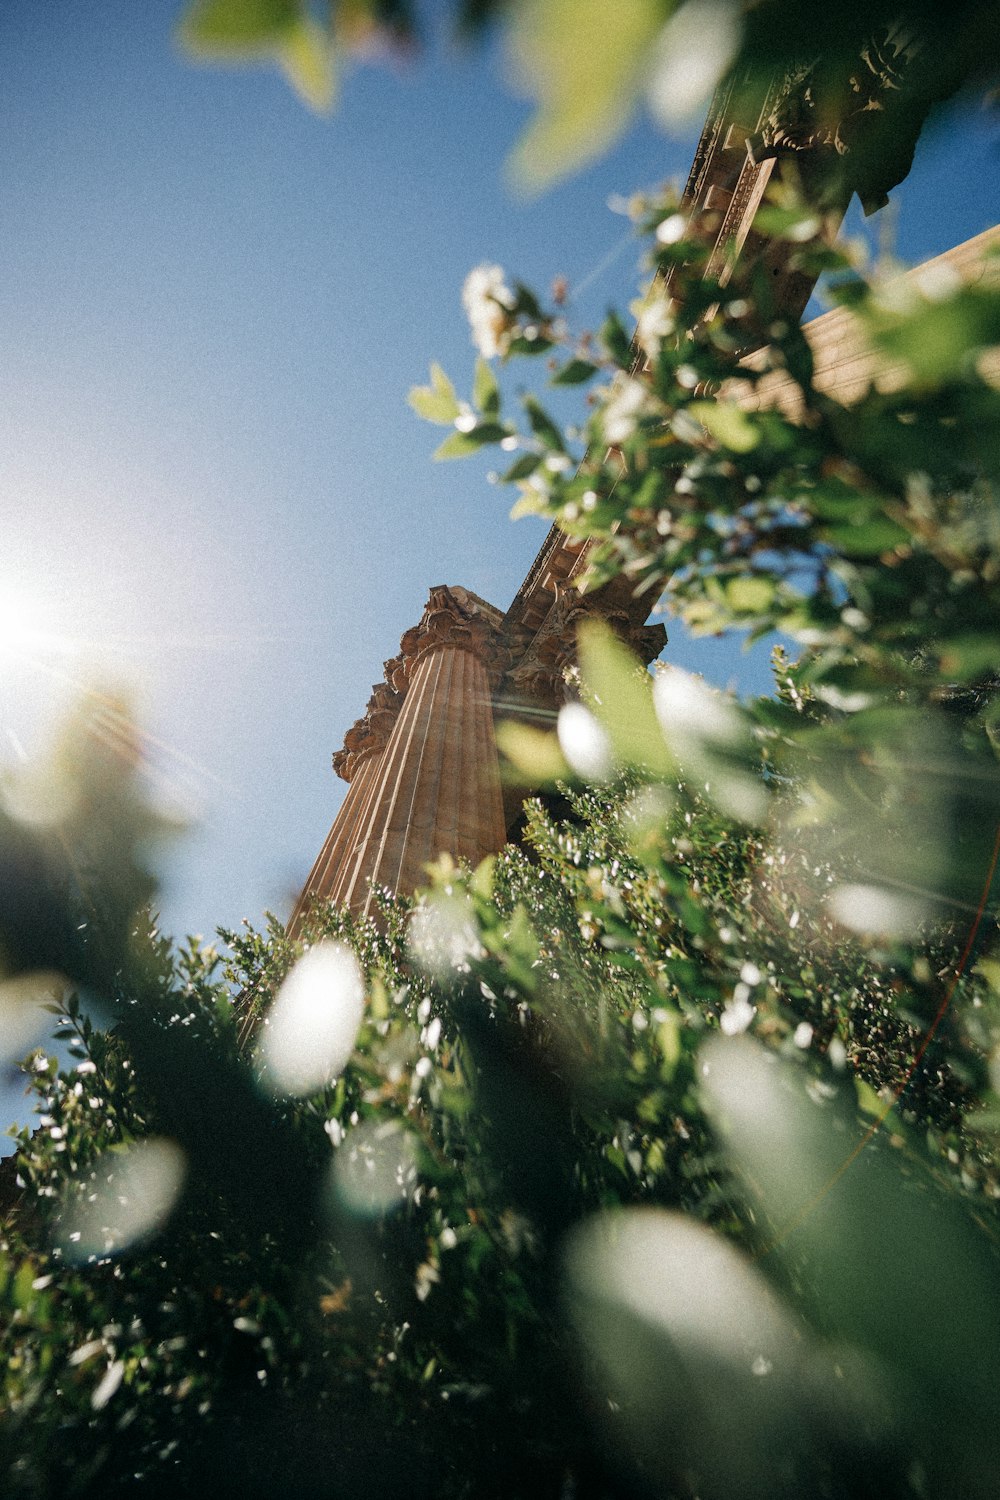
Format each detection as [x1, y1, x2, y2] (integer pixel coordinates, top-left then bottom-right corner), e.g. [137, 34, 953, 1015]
[0, 67, 1000, 1500]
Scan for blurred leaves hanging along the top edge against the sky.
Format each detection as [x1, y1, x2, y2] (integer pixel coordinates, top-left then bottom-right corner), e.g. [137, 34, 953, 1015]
[178, 0, 997, 187]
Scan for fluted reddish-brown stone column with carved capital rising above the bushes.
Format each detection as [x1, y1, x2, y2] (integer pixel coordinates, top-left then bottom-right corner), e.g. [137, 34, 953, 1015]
[289, 587, 505, 932]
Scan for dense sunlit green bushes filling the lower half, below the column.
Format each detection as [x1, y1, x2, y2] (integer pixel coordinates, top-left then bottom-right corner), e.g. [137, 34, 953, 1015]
[0, 663, 1000, 1497]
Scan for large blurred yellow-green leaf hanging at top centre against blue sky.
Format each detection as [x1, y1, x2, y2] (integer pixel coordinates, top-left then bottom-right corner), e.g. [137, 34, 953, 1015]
[508, 0, 672, 192]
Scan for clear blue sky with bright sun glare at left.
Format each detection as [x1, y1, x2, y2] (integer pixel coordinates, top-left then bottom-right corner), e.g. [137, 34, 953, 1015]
[0, 0, 1000, 972]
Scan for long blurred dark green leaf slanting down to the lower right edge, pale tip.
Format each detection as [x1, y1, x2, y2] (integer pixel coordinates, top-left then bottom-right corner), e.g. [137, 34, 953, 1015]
[702, 1038, 1000, 1496]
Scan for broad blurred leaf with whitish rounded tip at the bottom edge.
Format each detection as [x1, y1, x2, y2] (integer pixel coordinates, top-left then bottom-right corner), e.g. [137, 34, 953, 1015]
[565, 1209, 879, 1500]
